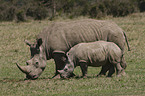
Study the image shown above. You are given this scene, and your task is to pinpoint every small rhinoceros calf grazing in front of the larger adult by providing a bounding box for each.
[58,41,125,78]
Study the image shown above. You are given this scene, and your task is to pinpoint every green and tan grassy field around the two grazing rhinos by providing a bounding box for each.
[0,13,145,96]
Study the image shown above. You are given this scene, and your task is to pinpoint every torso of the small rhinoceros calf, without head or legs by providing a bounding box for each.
[69,41,122,66]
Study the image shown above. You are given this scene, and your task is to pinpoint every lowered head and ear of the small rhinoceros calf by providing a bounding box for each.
[58,53,74,78]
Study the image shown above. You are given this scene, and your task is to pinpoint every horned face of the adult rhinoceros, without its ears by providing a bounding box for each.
[16,54,46,80]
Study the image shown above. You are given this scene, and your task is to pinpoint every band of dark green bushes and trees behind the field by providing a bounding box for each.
[0,0,145,21]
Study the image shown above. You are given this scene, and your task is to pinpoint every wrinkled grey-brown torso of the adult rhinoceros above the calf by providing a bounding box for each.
[38,19,124,55]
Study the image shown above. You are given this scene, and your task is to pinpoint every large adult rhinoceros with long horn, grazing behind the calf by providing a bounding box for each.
[17,19,129,79]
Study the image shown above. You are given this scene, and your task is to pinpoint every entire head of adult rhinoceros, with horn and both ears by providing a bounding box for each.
[17,38,46,79]
